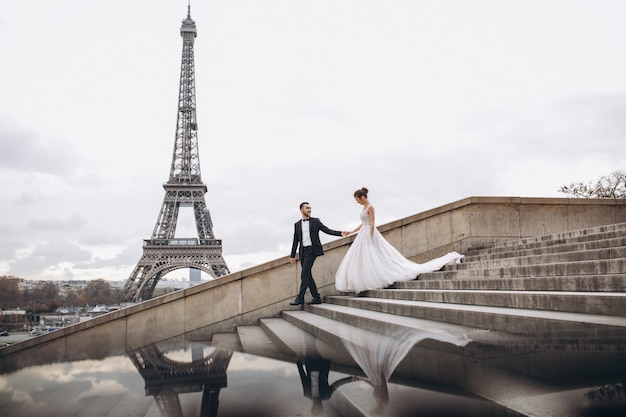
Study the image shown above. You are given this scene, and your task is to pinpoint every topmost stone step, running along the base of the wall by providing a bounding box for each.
[470,223,626,253]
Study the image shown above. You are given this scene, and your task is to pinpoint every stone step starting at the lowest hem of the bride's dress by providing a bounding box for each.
[368,289,626,317]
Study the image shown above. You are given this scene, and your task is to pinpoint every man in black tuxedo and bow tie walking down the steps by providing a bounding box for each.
[289,202,348,306]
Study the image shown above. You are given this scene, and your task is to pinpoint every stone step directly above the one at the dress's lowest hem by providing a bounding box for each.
[392,274,626,294]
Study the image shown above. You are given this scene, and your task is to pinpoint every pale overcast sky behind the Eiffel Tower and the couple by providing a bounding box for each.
[0,0,626,280]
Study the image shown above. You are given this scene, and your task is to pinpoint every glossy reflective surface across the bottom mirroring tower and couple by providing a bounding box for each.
[0,319,626,417]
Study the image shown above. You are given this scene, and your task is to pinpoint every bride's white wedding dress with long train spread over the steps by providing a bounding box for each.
[335,208,464,294]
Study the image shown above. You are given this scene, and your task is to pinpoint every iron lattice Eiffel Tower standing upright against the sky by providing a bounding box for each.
[124,5,230,301]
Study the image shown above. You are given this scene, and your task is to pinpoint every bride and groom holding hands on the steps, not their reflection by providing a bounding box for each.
[289,187,463,305]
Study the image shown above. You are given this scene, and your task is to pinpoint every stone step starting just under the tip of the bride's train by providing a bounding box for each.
[454,244,626,270]
